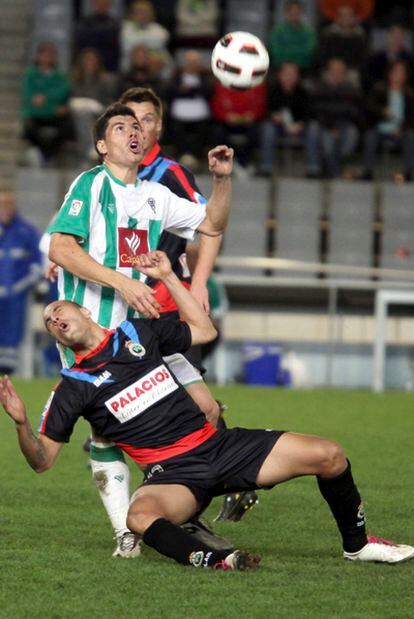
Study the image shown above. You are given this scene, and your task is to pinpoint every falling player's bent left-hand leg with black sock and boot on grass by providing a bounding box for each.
[127,484,259,569]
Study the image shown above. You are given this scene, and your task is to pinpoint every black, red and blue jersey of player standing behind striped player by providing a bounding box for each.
[137,144,206,312]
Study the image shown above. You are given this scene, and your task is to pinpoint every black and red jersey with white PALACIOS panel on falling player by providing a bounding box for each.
[39,317,215,464]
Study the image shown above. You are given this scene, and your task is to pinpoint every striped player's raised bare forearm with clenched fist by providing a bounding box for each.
[197,146,234,236]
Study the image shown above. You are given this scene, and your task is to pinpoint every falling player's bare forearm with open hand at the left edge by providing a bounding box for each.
[0,376,63,473]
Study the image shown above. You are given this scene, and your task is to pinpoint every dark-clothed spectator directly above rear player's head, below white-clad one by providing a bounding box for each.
[119,45,164,96]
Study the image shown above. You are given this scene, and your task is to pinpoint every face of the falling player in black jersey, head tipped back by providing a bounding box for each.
[43,301,91,348]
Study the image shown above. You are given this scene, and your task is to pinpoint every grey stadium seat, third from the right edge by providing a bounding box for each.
[274,178,322,278]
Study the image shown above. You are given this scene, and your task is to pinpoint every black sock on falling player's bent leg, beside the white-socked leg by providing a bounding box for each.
[142,518,229,567]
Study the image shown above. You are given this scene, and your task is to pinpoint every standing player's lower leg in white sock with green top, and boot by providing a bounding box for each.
[89,436,140,558]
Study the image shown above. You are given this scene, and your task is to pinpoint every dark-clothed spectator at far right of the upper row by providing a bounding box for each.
[365,26,413,86]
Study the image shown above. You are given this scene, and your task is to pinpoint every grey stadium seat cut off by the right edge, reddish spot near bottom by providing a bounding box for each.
[380,183,414,279]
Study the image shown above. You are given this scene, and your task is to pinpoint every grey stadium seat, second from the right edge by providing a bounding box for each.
[328,181,374,279]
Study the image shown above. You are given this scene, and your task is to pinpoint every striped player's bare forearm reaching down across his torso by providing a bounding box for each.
[49,232,160,318]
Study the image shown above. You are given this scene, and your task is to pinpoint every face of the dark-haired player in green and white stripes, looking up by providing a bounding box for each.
[97,116,144,168]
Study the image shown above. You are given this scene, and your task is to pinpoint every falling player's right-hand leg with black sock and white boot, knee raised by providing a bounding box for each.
[257,432,414,563]
